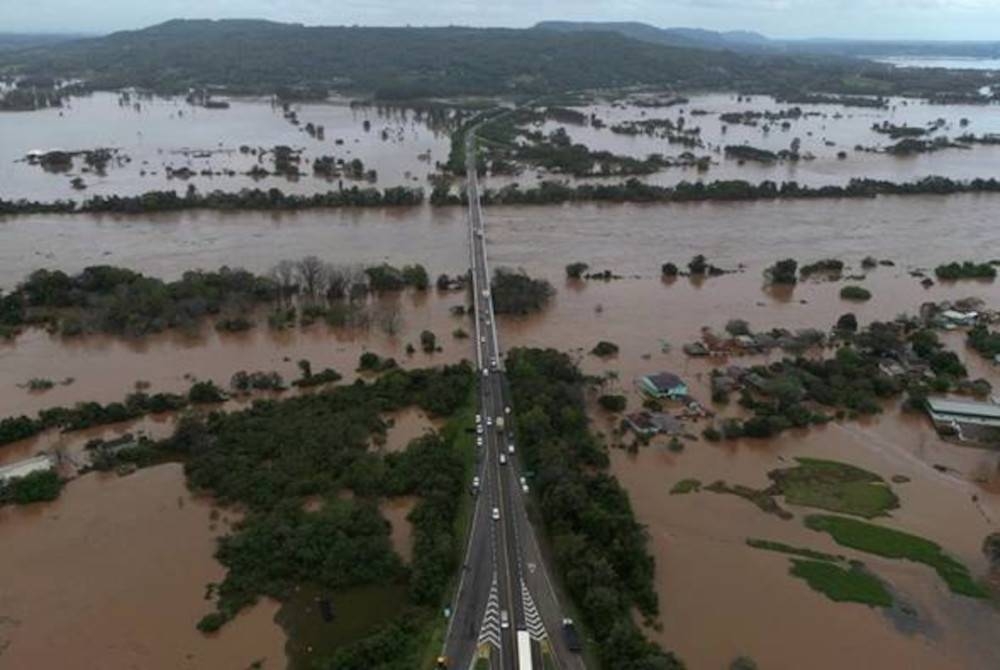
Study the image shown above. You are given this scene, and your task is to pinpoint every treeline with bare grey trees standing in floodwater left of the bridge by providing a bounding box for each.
[0,256,438,337]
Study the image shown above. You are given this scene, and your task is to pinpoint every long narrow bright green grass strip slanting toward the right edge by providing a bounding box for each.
[805,514,989,598]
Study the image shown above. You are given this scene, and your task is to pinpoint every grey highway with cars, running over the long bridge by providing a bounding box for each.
[442,123,584,670]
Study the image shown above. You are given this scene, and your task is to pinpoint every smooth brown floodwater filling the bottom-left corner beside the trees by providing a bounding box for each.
[0,465,285,670]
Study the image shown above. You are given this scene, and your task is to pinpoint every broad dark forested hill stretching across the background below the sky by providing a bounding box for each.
[0,20,988,98]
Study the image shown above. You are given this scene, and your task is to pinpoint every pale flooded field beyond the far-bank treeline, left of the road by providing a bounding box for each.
[0,93,449,200]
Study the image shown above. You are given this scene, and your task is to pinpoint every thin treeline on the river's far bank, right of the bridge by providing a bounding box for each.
[474,177,1000,205]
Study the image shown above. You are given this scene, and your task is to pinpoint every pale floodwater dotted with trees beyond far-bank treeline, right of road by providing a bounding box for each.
[536,94,1000,185]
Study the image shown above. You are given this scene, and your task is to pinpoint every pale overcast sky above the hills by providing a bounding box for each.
[0,0,1000,40]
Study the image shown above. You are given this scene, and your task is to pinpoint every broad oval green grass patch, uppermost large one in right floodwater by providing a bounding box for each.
[767,458,899,519]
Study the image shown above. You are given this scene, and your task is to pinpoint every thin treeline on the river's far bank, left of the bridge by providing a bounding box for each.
[0,186,424,215]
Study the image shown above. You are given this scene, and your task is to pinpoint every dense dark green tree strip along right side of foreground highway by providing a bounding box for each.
[507,349,683,670]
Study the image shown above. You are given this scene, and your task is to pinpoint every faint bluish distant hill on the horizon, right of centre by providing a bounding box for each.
[535,21,782,51]
